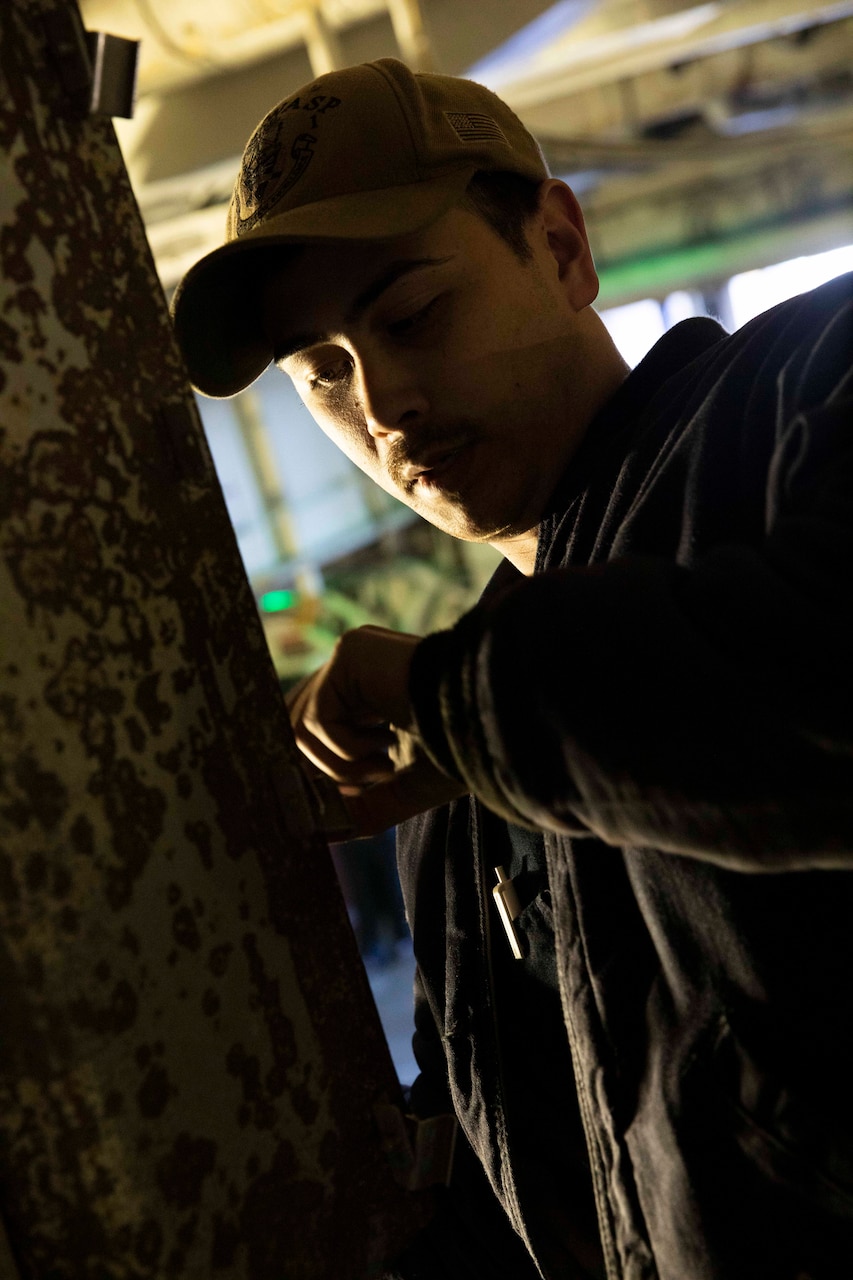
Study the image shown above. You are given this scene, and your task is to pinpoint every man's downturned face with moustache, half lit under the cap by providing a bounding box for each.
[258,192,601,547]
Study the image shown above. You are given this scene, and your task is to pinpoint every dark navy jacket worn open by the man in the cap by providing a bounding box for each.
[398,276,853,1280]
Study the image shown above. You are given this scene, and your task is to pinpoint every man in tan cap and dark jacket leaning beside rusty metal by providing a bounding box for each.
[174,60,853,1280]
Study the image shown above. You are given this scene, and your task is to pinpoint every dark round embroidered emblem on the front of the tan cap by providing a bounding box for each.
[232,93,341,234]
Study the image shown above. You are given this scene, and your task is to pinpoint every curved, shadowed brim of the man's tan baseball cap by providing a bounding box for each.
[172,168,475,399]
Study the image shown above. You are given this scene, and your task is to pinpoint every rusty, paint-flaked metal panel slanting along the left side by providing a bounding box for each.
[0,0,427,1280]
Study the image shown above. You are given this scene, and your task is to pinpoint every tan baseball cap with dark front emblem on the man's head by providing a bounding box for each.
[172,58,548,398]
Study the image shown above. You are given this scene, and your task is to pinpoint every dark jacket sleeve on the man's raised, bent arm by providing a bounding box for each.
[411,372,853,872]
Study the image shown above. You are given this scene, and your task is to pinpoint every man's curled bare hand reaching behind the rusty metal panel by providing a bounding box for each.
[287,626,465,836]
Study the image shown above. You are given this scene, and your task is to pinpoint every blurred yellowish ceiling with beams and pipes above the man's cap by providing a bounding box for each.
[81,0,853,305]
